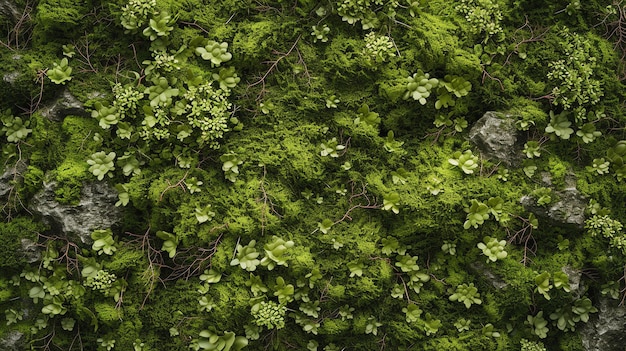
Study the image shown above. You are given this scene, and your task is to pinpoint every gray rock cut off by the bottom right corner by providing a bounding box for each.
[580,298,626,351]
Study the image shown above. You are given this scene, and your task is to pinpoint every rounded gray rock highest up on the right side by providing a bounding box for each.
[469,111,521,166]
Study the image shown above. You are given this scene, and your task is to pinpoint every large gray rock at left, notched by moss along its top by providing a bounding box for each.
[29,182,121,244]
